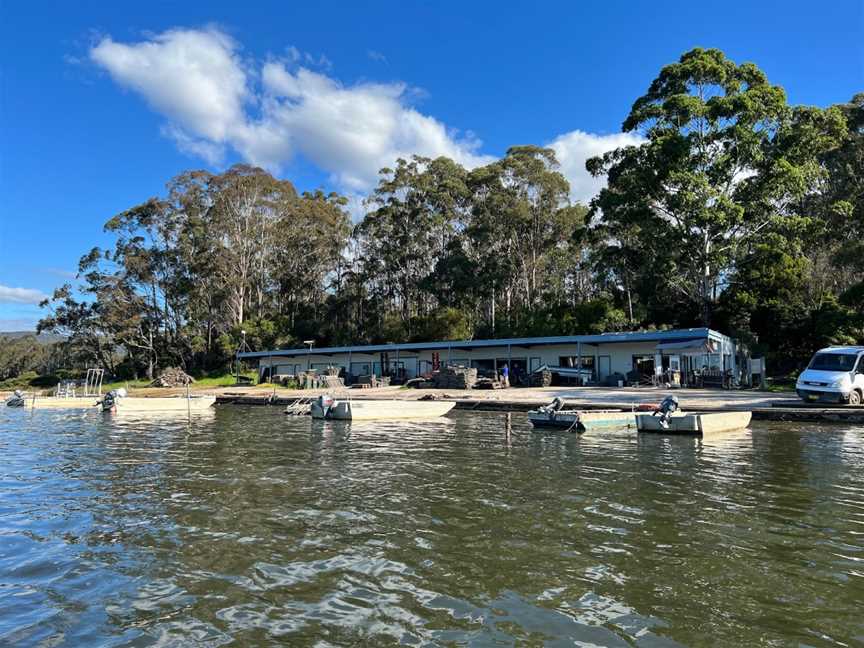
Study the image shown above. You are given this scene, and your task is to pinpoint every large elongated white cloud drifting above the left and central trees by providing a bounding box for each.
[90,28,492,191]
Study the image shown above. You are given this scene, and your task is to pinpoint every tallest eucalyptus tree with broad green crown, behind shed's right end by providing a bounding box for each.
[587,48,841,325]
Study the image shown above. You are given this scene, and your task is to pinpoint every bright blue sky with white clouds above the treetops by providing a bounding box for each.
[0,0,864,330]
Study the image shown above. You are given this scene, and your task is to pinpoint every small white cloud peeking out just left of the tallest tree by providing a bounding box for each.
[548,130,645,205]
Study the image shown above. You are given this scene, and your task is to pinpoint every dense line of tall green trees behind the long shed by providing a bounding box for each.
[40,49,864,376]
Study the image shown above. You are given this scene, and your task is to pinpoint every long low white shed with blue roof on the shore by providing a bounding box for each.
[239,328,744,383]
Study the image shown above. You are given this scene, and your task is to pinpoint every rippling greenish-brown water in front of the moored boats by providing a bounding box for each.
[0,408,864,647]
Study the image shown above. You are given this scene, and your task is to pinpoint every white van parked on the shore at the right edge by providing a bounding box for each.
[795,347,864,405]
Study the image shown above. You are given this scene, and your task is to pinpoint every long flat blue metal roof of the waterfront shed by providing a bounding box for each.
[239,328,728,358]
